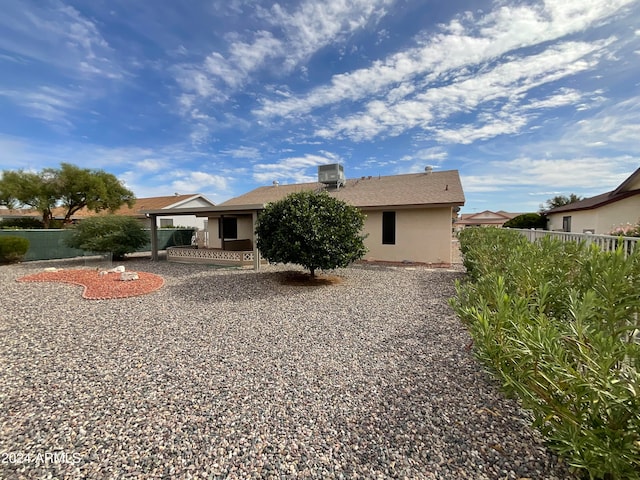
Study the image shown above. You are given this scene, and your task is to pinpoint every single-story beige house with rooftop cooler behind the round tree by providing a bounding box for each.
[144,164,465,268]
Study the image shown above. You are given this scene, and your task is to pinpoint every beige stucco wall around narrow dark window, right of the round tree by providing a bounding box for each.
[364,207,452,263]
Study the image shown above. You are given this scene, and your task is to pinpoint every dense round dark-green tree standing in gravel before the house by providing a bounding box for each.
[256,192,367,277]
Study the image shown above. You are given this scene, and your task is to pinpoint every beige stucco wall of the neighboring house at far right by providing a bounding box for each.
[547,195,640,234]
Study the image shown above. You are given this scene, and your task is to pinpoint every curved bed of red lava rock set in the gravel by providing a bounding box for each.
[17,269,164,300]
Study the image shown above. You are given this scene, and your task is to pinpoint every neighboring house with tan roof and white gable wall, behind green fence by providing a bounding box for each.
[0,193,215,230]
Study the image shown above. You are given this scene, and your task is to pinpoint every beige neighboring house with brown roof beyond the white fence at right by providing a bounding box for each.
[547,168,640,234]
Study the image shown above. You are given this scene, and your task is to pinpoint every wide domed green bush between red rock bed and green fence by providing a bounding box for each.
[66,215,149,260]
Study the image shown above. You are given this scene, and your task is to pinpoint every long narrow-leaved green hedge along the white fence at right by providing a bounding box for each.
[451,229,640,480]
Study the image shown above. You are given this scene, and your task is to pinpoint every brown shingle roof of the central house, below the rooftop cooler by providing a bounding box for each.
[219,170,465,208]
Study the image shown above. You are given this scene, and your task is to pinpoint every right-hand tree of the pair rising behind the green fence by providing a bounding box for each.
[55,163,135,224]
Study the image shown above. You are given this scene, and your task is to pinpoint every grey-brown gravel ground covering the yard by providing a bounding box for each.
[0,258,571,480]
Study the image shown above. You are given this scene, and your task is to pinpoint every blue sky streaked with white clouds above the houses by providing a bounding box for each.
[0,0,640,213]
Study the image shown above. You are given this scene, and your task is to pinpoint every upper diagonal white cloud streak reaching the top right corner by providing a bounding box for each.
[254,0,633,117]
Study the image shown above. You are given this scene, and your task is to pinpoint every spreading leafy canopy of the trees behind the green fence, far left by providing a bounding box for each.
[0,163,135,228]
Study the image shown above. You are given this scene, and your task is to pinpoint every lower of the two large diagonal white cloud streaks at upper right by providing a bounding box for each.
[316,40,611,143]
